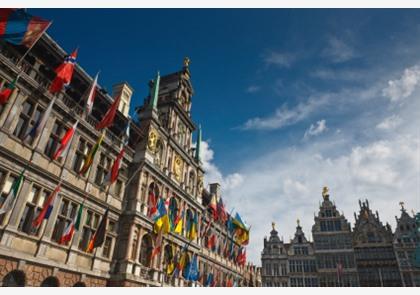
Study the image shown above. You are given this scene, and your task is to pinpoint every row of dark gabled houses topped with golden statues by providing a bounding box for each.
[261,188,420,287]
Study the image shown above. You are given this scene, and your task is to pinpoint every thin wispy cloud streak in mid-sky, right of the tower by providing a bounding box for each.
[239,95,329,130]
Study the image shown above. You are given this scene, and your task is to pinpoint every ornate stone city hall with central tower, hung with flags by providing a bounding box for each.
[0,34,260,286]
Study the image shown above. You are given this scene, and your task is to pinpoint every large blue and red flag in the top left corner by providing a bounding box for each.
[0,8,51,47]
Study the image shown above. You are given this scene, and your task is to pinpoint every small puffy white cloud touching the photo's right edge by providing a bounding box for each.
[383,65,420,102]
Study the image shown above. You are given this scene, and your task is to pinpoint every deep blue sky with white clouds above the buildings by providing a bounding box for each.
[29,9,420,264]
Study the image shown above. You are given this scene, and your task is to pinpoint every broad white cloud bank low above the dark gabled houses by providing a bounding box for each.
[218,63,420,264]
